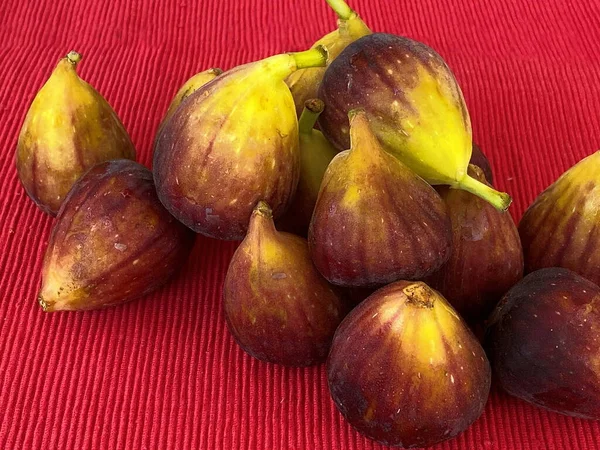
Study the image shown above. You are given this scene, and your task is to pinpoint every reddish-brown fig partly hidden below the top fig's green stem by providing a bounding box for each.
[427,165,523,324]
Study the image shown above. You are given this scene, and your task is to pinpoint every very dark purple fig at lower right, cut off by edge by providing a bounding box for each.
[488,267,600,420]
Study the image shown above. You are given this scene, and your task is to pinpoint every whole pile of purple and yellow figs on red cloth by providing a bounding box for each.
[16,0,600,447]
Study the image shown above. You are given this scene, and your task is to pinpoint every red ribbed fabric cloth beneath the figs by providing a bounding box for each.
[0,0,600,450]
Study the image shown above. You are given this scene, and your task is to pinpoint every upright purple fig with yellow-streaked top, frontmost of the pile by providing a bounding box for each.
[327,281,491,448]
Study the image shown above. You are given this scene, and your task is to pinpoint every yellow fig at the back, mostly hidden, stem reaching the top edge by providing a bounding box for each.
[286,0,371,117]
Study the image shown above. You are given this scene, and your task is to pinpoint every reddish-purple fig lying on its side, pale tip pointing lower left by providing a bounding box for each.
[38,160,195,311]
